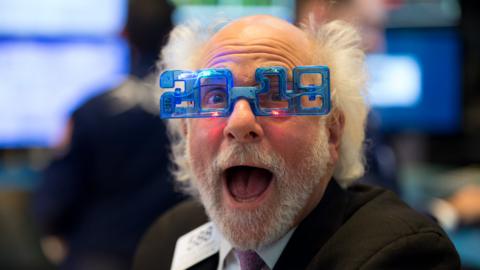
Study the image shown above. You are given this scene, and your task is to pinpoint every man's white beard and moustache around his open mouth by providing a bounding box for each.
[187,126,330,249]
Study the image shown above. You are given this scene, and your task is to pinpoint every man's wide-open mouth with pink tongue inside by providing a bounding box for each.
[228,167,272,200]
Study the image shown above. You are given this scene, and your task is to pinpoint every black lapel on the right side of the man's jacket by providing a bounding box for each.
[274,179,348,270]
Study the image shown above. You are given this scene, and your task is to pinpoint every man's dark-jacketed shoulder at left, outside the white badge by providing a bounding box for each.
[133,200,208,270]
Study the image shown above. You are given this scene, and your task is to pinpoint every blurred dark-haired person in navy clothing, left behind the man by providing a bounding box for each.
[30,0,181,270]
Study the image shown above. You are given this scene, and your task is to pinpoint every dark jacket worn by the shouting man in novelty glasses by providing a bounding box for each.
[134,180,460,270]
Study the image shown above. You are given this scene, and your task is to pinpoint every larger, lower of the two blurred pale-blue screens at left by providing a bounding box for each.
[0,39,129,148]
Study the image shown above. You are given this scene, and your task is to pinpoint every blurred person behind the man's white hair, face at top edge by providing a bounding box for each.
[296,0,401,195]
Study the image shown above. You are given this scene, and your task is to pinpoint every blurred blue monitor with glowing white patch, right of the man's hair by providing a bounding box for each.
[367,28,462,133]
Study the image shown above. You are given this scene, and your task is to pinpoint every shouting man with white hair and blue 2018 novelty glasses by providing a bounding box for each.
[134,16,460,270]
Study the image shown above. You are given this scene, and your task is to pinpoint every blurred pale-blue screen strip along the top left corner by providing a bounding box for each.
[0,0,127,36]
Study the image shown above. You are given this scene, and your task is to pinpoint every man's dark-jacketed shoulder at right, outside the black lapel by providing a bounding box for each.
[317,186,460,269]
